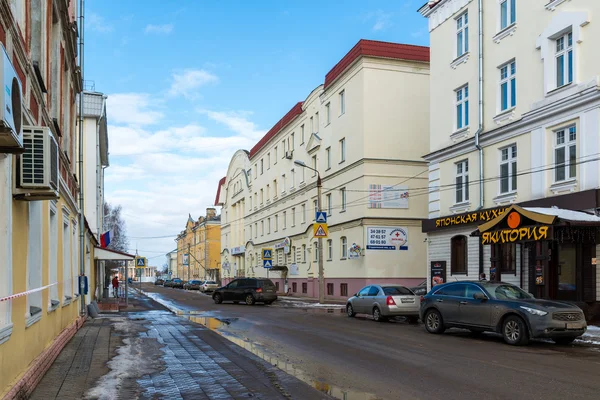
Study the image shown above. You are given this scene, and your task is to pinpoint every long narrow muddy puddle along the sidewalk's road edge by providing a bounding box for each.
[185,312,380,400]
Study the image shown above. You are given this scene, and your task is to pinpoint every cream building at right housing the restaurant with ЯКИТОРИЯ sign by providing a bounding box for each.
[420,0,600,310]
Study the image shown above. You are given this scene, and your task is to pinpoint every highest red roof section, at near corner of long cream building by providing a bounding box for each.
[325,39,429,88]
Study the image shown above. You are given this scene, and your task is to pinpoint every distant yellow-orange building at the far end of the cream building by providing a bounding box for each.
[172,208,221,281]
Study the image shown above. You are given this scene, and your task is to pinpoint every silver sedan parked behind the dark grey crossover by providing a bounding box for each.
[346,285,421,322]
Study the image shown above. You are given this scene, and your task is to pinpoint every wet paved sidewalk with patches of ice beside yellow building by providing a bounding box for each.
[31,291,328,400]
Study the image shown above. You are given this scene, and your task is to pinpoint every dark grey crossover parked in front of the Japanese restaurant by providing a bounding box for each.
[421,281,587,345]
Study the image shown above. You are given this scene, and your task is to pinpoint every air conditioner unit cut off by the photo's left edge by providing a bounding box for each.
[0,44,25,153]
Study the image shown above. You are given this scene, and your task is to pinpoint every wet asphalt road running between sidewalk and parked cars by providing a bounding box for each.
[138,285,600,400]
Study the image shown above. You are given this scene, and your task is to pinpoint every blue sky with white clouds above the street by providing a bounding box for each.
[84,0,429,267]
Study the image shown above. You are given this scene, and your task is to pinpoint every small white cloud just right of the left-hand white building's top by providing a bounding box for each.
[106,93,164,125]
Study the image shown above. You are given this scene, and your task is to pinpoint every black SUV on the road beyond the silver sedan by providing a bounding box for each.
[212,278,277,305]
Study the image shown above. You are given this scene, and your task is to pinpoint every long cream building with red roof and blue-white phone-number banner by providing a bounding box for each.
[216,40,429,297]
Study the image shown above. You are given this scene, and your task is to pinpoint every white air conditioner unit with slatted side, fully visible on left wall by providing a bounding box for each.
[15,126,59,201]
